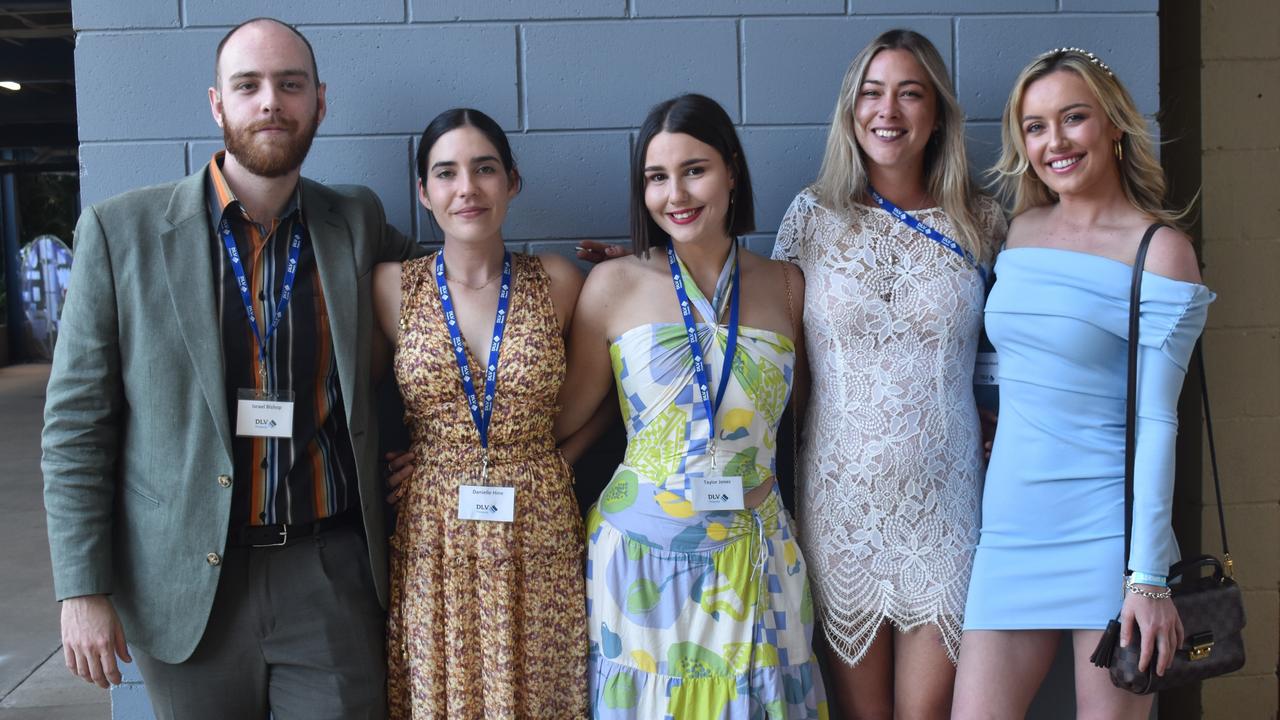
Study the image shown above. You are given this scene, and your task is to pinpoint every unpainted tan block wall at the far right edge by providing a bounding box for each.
[1199,0,1280,720]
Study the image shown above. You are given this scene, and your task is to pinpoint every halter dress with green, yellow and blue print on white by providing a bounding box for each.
[586,248,827,720]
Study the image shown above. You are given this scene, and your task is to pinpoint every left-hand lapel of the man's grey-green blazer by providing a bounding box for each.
[160,170,232,457]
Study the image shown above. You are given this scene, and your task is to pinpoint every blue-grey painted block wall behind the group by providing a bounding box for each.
[72,0,1158,720]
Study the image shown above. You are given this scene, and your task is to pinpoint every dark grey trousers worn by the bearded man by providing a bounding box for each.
[133,520,387,720]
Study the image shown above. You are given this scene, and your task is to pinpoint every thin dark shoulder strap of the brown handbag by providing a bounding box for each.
[1124,223,1233,578]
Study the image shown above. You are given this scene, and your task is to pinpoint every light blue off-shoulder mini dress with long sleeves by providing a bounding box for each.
[965,247,1215,630]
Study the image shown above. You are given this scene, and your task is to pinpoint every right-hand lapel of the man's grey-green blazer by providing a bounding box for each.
[302,179,360,423]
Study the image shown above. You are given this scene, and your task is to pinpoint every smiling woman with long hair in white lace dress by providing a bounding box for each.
[773,29,1005,717]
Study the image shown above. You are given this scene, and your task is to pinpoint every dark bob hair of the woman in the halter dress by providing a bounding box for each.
[631,94,755,255]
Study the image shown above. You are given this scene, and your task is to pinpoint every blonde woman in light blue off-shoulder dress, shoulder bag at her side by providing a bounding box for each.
[952,49,1213,719]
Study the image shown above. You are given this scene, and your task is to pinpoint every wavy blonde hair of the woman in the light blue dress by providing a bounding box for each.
[988,47,1190,227]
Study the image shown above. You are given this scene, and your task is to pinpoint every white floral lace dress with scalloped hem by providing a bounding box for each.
[773,190,1006,665]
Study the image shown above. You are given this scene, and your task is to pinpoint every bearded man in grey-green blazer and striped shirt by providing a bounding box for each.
[42,18,415,719]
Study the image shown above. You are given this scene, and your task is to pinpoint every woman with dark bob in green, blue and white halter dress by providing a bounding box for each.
[557,95,826,720]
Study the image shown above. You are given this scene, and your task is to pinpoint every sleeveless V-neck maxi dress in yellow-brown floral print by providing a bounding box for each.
[387,254,588,720]
